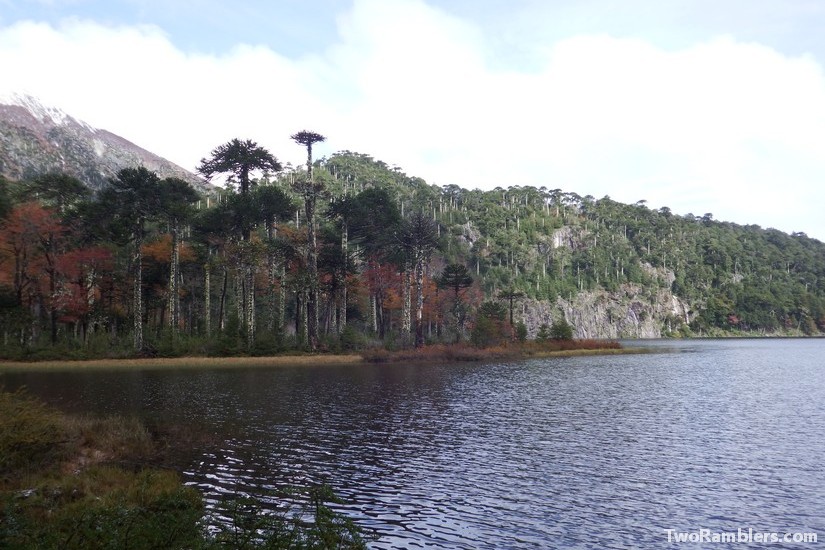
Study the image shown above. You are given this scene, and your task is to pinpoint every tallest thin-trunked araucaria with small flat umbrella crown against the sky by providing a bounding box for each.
[291,130,326,350]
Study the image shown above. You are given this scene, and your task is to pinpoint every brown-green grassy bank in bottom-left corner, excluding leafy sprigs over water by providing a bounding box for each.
[0,391,203,548]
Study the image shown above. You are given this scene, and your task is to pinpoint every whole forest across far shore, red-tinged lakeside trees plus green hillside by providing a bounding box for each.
[0,140,825,358]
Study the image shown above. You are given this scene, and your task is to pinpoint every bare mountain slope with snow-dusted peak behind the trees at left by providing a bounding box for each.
[0,94,210,192]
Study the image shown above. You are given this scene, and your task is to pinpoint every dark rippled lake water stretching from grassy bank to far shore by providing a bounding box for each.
[0,339,825,548]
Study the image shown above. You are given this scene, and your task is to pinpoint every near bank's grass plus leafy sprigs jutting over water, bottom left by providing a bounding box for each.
[0,391,367,549]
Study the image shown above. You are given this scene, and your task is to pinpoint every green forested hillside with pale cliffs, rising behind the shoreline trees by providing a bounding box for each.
[322,152,825,337]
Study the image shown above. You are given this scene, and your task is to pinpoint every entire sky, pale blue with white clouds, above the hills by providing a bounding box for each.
[0,0,825,240]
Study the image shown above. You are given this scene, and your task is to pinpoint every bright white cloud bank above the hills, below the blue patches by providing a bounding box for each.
[0,0,825,239]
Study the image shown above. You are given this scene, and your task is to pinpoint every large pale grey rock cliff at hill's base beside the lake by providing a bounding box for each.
[521,284,692,338]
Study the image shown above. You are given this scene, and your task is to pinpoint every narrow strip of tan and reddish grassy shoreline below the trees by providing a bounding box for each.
[0,347,651,373]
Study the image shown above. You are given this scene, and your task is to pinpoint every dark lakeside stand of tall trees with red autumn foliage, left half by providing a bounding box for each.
[0,137,502,356]
